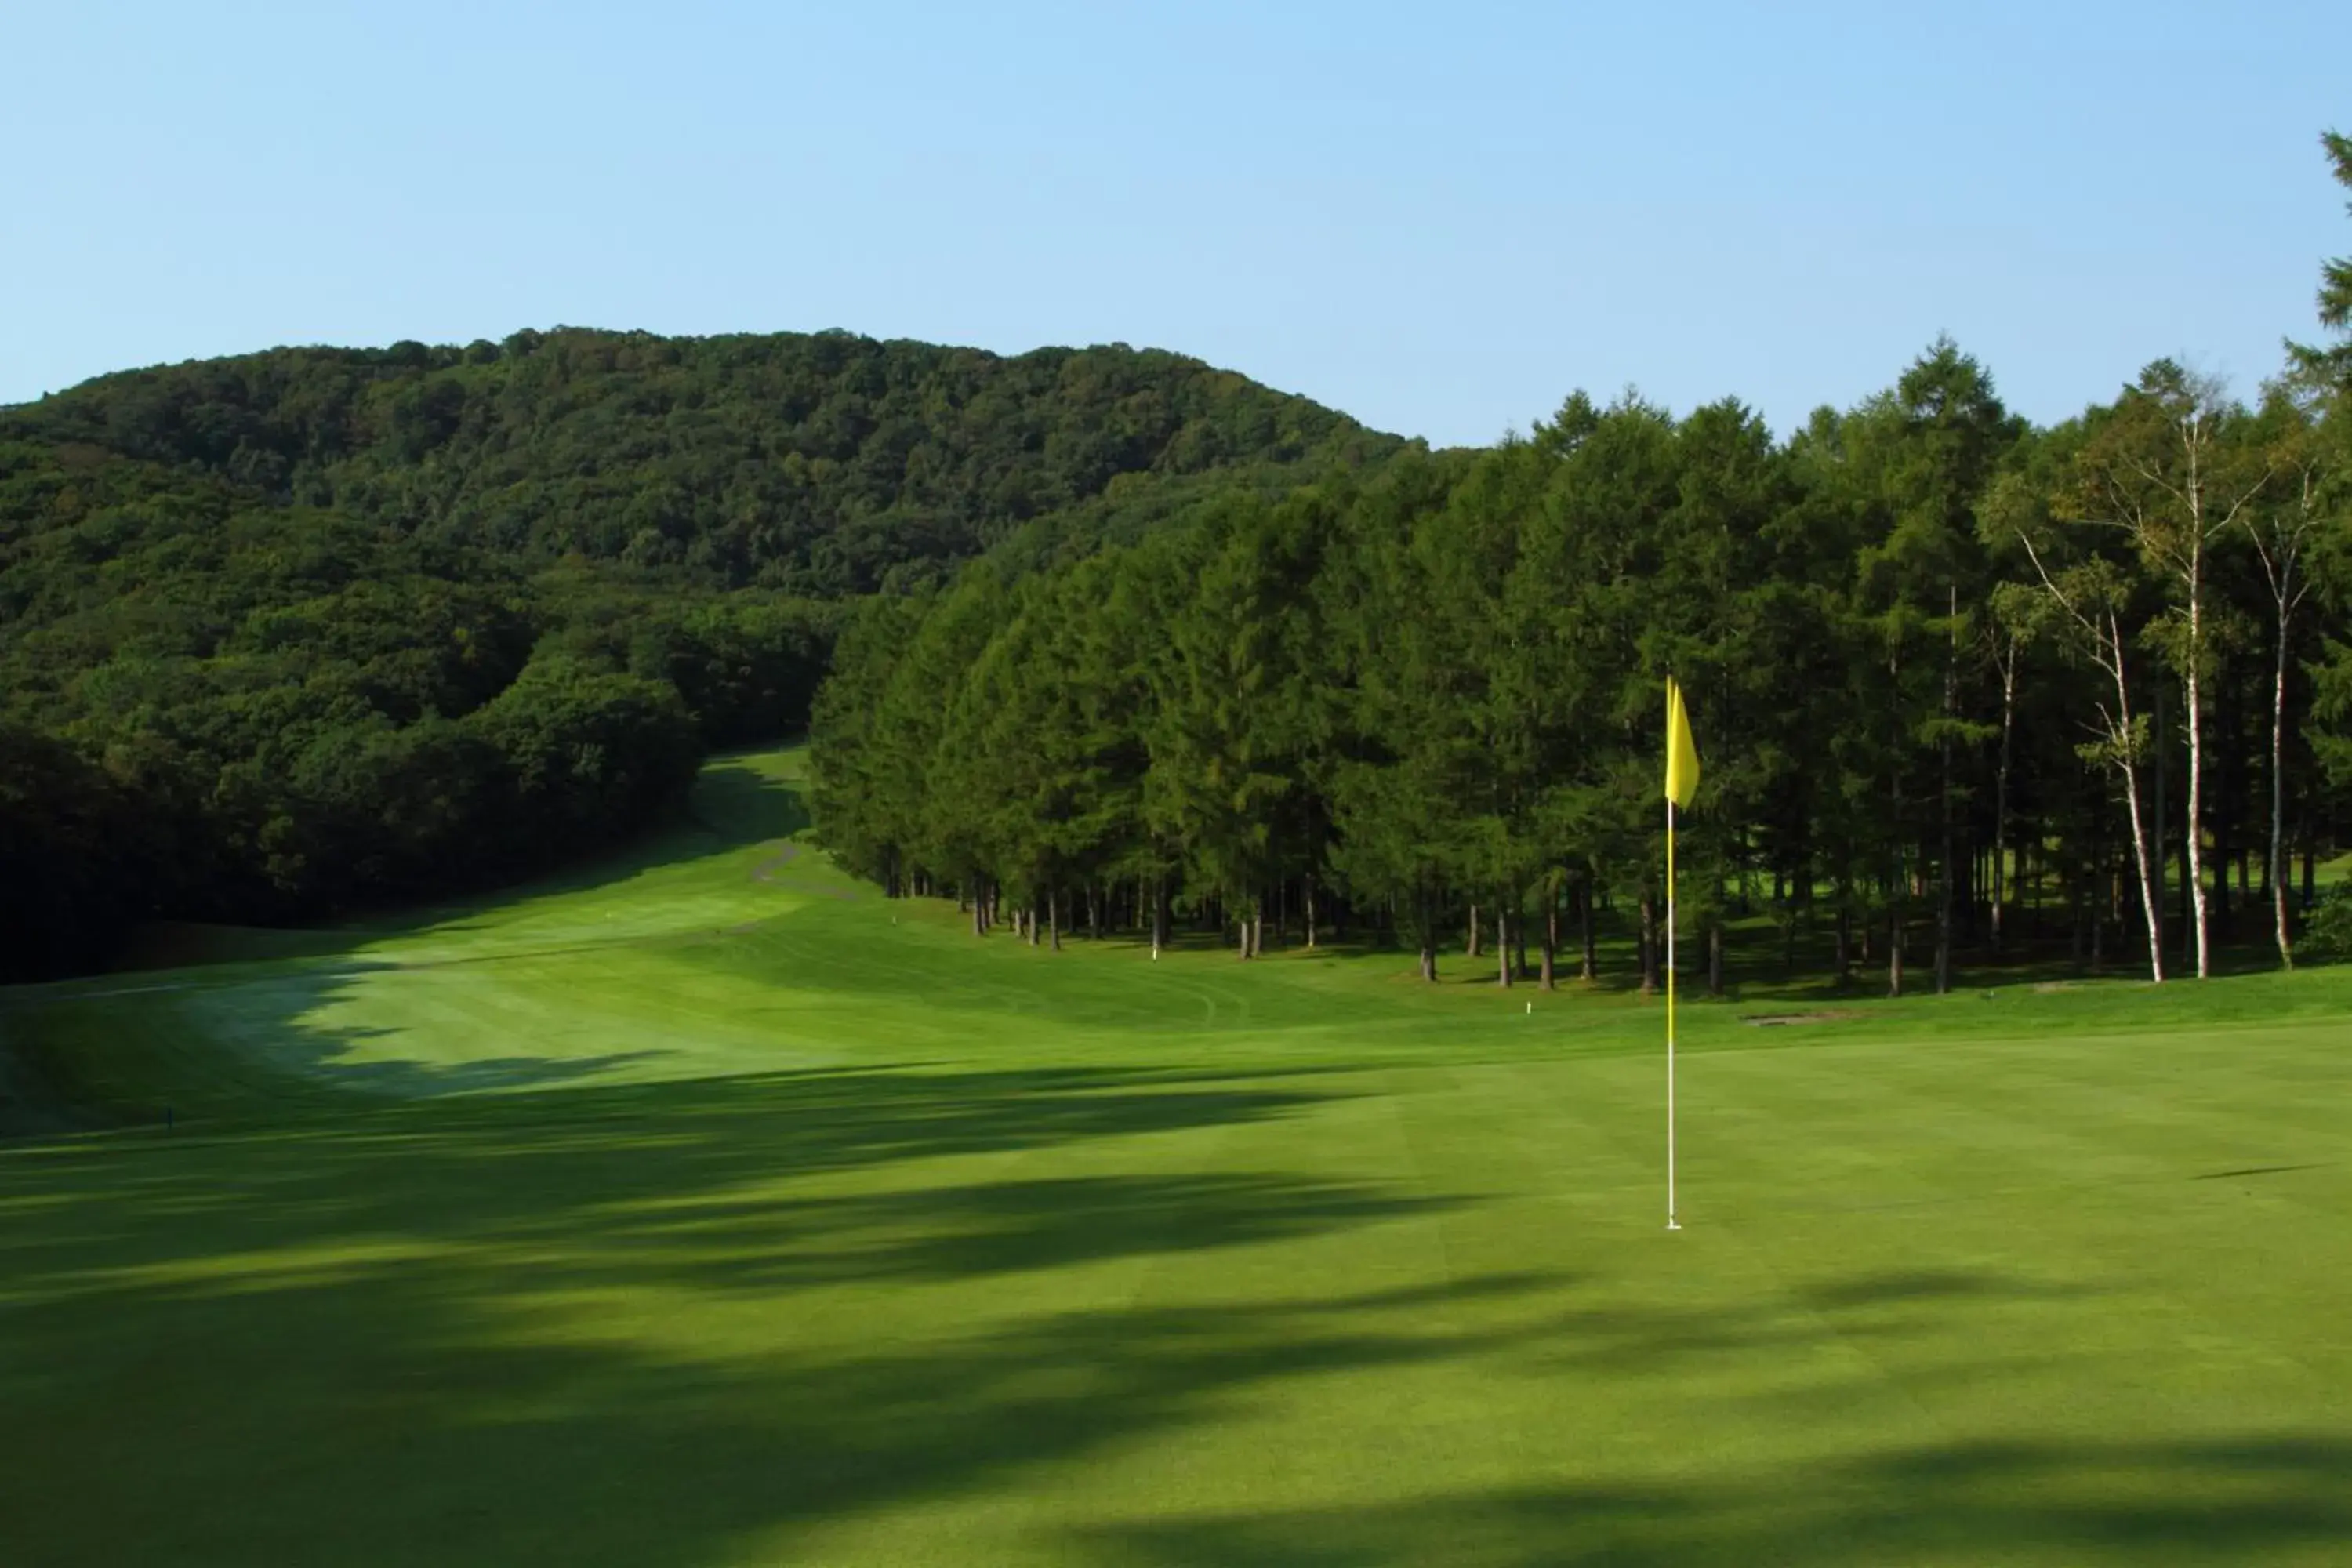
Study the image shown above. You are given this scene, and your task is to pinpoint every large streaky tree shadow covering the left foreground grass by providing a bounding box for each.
[0,1053,1545,1566]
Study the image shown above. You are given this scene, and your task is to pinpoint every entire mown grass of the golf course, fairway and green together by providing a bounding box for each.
[0,753,2352,1568]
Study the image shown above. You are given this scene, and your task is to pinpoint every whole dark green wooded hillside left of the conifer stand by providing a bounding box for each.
[0,329,1404,978]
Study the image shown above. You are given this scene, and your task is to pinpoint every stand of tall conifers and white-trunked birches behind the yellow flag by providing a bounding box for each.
[814,136,2352,992]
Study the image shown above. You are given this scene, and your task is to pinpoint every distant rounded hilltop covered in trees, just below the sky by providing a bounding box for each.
[0,329,1402,597]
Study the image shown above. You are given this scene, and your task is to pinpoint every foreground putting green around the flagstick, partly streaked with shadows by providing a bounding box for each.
[0,1041,2352,1566]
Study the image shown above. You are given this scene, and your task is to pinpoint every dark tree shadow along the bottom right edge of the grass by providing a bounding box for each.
[1098,1436,2352,1568]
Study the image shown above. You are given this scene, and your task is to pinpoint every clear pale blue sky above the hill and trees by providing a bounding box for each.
[0,0,2352,442]
